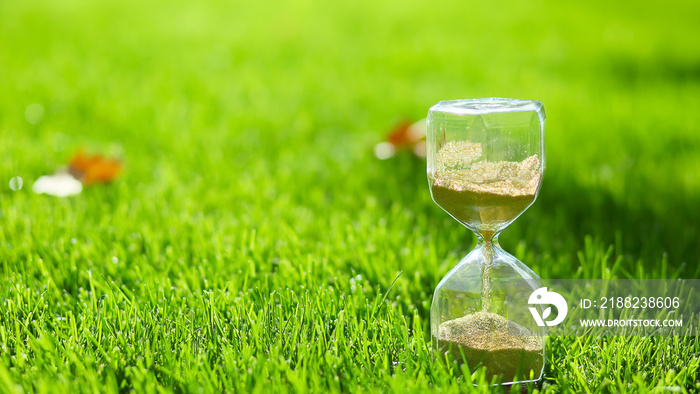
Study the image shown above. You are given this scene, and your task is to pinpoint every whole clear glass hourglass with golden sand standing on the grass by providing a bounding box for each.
[426,98,545,385]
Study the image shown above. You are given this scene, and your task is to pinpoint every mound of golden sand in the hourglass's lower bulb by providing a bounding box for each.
[438,311,544,381]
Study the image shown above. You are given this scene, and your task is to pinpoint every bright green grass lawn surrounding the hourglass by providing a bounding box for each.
[0,0,700,392]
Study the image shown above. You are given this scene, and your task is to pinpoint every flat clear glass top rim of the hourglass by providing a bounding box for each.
[430,97,545,119]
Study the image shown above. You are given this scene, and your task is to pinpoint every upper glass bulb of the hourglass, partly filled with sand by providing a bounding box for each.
[426,98,545,238]
